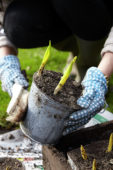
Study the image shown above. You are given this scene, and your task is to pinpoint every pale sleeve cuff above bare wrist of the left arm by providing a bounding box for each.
[0,28,17,53]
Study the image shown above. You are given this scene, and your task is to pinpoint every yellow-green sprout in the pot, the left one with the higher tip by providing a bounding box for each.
[37,41,51,77]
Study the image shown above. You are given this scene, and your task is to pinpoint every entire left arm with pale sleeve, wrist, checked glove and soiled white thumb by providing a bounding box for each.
[0,33,29,122]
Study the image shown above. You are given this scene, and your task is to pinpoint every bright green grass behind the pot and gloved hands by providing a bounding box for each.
[0,47,113,129]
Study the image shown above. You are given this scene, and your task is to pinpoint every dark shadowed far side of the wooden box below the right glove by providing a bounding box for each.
[55,120,113,153]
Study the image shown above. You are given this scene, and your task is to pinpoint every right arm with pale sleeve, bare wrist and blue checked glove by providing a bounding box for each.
[63,27,113,135]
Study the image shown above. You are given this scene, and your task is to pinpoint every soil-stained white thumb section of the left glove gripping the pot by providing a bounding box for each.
[6,84,29,123]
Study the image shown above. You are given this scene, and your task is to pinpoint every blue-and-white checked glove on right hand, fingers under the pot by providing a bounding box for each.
[63,67,107,135]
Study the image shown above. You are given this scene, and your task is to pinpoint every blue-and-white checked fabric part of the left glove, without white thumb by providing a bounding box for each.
[0,55,28,96]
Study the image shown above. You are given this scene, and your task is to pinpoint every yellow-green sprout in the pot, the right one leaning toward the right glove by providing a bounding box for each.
[54,57,77,95]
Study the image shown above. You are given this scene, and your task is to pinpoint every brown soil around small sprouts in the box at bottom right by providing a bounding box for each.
[68,140,113,170]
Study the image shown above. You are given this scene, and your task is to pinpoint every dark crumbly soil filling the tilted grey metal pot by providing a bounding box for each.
[34,70,82,110]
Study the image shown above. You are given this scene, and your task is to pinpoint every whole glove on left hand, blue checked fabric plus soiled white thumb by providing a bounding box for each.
[0,55,28,122]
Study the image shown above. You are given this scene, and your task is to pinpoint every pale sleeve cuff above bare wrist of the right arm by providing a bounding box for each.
[101,27,113,56]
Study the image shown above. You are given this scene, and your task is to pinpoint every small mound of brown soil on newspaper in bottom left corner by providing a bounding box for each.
[0,158,25,170]
